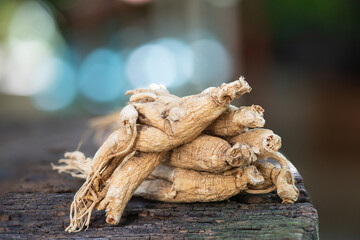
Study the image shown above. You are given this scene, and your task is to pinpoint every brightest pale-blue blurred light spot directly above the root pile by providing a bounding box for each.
[125,38,195,88]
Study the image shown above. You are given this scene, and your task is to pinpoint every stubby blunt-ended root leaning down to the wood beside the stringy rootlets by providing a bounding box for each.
[98,152,165,225]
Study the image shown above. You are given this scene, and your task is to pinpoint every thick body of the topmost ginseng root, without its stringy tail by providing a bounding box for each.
[133,78,251,152]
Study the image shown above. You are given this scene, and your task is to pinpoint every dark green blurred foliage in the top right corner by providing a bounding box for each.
[265,0,360,40]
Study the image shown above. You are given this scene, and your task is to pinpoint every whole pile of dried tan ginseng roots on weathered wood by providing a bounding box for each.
[53,77,299,232]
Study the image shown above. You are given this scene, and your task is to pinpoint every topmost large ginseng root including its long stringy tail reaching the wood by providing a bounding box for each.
[58,78,251,232]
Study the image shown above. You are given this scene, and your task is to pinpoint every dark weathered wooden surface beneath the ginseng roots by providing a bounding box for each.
[0,117,318,239]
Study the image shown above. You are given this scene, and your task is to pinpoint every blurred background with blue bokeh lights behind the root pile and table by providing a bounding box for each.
[0,0,360,239]
